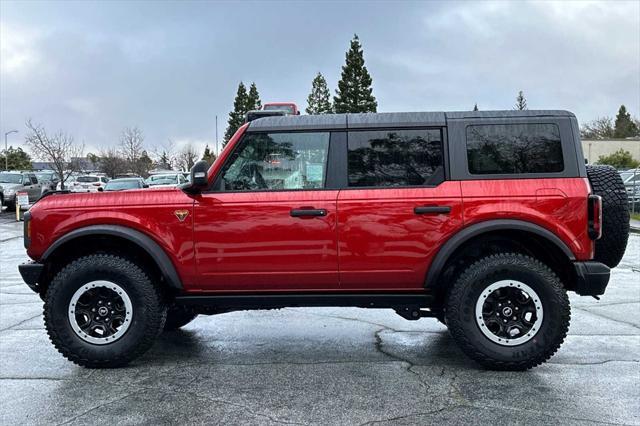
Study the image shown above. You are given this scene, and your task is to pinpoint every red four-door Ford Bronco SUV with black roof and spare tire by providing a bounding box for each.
[20,111,629,370]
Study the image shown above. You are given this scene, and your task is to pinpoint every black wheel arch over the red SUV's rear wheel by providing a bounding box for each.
[424,219,576,289]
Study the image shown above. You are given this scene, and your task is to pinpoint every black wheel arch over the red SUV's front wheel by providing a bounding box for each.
[40,225,183,290]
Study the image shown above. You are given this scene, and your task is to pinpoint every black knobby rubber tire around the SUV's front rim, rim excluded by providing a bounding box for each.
[44,254,166,368]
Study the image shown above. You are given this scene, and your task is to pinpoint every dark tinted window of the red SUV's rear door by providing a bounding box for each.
[347,129,444,187]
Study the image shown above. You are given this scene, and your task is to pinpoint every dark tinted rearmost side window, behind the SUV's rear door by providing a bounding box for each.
[466,124,564,175]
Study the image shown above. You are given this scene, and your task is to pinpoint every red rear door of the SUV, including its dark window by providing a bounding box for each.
[338,128,462,291]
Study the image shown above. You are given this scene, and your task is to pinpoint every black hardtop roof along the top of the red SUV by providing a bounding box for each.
[247,110,574,132]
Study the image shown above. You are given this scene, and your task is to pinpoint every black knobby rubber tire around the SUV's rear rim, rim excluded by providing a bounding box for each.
[446,253,571,370]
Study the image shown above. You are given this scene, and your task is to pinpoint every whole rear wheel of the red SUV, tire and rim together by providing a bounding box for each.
[446,253,571,370]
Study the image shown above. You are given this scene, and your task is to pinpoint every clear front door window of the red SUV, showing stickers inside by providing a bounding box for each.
[222,132,329,191]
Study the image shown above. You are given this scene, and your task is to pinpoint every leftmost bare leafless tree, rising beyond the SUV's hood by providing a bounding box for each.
[25,120,84,189]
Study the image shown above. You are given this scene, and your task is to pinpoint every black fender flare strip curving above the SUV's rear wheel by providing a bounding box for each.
[424,219,576,288]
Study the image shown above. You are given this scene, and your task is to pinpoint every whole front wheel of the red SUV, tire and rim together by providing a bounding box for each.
[44,254,166,368]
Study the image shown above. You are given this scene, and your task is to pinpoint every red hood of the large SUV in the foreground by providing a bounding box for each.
[32,188,193,210]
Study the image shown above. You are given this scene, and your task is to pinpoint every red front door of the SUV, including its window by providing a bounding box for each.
[194,132,338,292]
